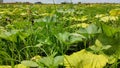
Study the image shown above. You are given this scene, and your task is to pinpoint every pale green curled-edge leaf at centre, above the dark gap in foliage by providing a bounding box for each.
[56,32,85,44]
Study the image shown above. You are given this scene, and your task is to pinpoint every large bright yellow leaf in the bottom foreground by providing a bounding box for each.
[64,49,108,68]
